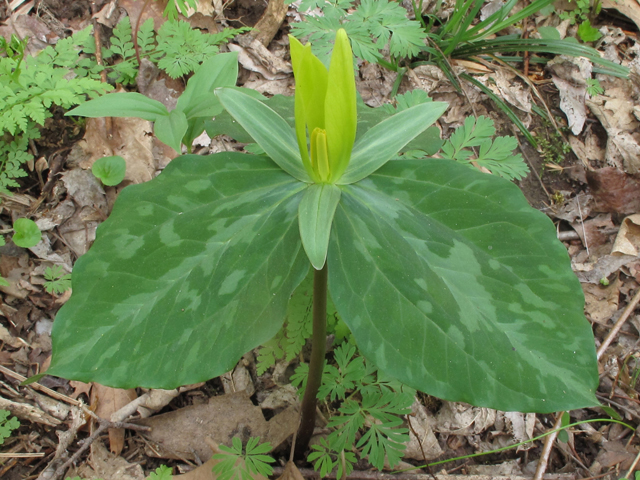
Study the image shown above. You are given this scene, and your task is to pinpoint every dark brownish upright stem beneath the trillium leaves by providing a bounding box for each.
[295,263,327,458]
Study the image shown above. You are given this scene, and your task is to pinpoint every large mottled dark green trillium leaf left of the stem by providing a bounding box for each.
[47,152,309,388]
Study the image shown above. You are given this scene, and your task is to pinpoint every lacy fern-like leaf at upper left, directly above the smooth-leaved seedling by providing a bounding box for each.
[76,16,250,85]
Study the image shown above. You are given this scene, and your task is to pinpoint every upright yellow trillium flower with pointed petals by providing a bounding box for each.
[289,29,357,183]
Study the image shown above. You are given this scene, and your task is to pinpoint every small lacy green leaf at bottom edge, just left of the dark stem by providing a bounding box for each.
[213,437,275,480]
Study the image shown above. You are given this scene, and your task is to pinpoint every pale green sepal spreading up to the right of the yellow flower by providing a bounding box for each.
[338,102,448,184]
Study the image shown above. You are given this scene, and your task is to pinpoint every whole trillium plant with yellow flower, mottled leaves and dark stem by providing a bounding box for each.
[47,30,598,454]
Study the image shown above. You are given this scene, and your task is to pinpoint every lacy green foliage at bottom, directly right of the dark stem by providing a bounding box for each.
[292,344,415,472]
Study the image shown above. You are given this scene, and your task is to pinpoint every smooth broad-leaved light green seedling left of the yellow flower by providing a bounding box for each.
[66,53,238,153]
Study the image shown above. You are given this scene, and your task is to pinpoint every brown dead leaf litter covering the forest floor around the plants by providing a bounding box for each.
[0,0,640,480]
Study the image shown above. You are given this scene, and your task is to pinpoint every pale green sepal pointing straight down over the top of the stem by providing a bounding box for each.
[298,183,341,270]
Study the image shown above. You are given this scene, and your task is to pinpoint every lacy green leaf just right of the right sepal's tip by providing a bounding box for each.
[442,116,529,180]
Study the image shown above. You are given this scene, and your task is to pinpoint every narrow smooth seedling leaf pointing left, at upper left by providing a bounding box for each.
[65,92,169,122]
